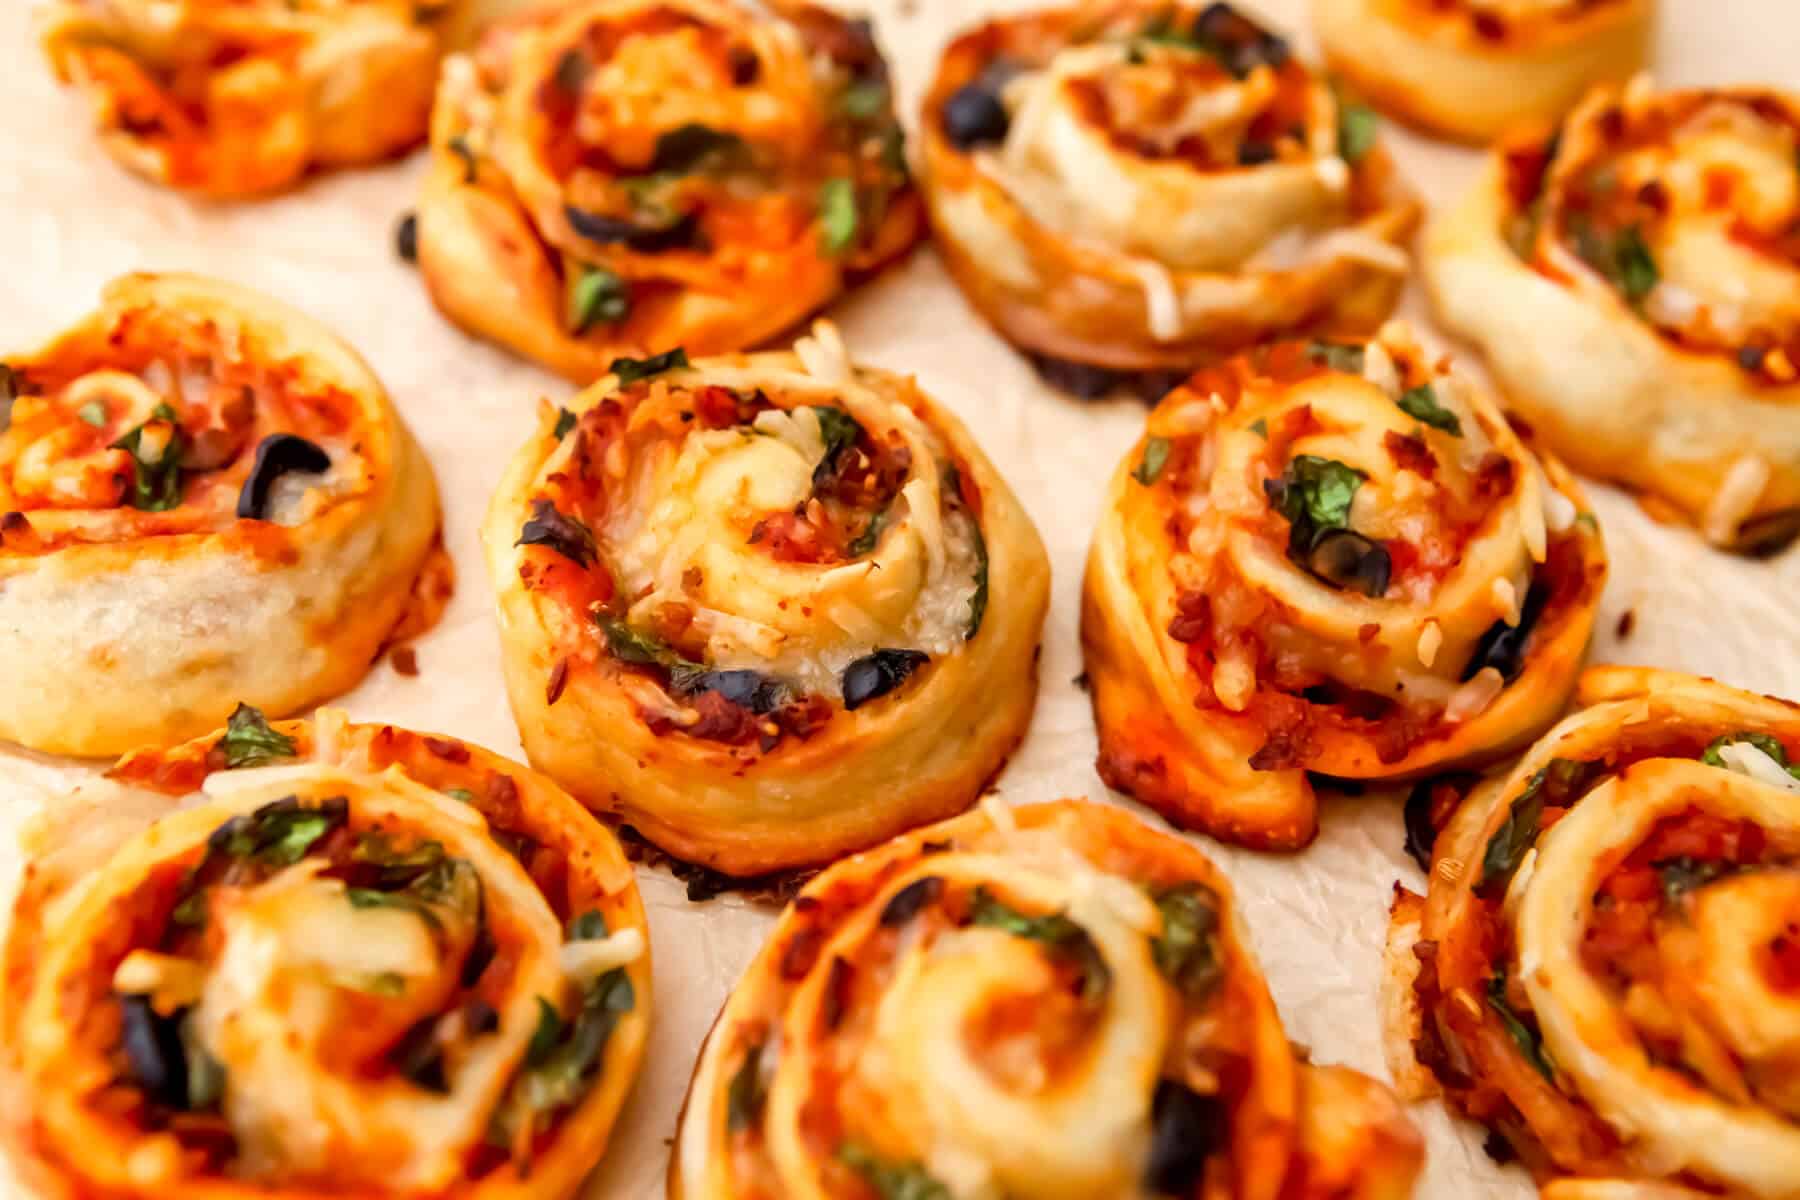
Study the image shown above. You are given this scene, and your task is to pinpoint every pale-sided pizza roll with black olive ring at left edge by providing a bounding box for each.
[0,275,452,756]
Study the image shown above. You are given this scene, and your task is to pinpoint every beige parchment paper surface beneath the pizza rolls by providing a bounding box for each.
[0,0,1800,1200]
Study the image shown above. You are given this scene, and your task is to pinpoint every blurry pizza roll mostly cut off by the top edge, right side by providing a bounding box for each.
[1312,0,1656,142]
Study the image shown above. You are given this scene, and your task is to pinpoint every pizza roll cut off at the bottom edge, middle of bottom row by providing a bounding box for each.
[668,801,1422,1200]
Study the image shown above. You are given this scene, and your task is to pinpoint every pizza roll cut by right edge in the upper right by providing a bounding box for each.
[1426,81,1800,549]
